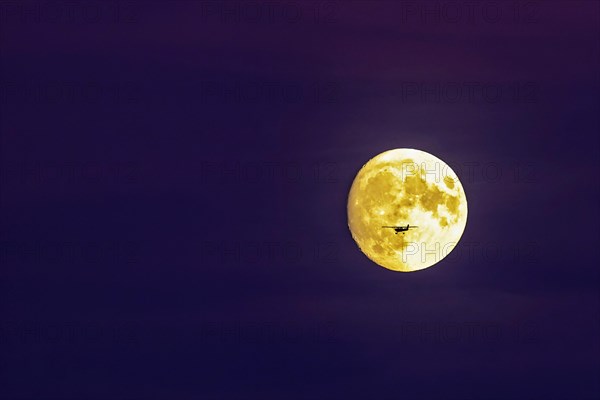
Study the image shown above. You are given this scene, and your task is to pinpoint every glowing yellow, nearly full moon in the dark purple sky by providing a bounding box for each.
[348,149,467,272]
